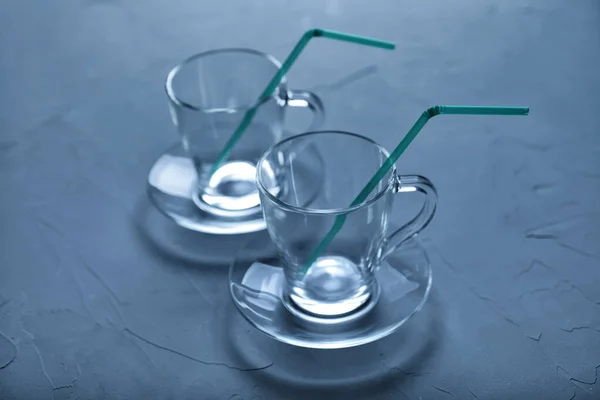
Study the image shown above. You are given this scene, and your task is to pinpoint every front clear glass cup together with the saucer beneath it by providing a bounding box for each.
[230,131,437,348]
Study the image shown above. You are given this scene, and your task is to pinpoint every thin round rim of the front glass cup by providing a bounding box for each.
[256,130,396,215]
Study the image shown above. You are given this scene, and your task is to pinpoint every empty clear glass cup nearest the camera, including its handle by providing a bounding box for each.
[257,131,437,318]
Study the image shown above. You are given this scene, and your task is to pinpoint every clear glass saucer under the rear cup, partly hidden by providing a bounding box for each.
[147,143,322,235]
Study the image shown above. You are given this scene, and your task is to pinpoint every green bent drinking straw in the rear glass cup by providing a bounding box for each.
[210,29,396,176]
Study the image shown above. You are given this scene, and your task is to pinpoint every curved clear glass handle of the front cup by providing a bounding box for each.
[381,175,437,258]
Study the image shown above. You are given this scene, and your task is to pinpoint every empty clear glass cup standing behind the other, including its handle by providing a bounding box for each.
[166,49,323,220]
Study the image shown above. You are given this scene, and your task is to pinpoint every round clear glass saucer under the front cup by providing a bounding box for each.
[229,237,432,349]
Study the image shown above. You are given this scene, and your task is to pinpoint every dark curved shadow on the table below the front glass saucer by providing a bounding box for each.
[226,290,444,399]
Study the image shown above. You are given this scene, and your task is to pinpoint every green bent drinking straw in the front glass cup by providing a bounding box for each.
[303,106,529,274]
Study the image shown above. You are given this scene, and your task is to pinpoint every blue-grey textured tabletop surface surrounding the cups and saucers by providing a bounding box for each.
[0,0,600,400]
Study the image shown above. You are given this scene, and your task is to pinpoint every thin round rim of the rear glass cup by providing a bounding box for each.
[165,47,286,111]
